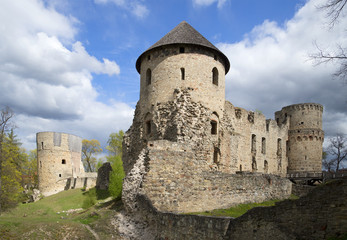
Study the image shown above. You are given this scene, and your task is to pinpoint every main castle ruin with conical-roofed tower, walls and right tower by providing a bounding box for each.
[122,22,324,212]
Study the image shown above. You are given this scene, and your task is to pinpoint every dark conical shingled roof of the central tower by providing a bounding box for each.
[136,21,230,73]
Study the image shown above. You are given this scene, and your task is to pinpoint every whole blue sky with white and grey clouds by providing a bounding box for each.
[0,0,347,153]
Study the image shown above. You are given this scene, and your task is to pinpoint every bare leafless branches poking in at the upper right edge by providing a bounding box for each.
[311,0,347,82]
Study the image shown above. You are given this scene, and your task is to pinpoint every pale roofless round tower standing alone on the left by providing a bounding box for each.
[36,132,84,196]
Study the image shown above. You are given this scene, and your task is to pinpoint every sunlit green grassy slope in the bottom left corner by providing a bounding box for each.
[0,189,121,239]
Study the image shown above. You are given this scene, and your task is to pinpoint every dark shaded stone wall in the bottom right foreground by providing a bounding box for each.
[134,179,347,240]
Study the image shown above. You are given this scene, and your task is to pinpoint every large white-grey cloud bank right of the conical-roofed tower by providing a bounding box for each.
[218,0,347,139]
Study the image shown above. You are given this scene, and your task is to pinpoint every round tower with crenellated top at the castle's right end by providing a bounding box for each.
[275,103,324,173]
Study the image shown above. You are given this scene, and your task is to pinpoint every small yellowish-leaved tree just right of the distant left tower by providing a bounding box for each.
[82,139,102,172]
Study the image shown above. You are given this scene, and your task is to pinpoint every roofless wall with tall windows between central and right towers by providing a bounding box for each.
[225,102,288,176]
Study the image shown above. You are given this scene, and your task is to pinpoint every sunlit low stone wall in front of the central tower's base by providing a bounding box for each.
[141,140,291,212]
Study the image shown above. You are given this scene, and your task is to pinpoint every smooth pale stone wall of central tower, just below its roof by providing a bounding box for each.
[139,45,225,117]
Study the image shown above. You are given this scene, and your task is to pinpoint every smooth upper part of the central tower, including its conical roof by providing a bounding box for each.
[136,21,230,117]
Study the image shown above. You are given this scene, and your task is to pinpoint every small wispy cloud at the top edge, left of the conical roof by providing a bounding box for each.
[94,0,149,18]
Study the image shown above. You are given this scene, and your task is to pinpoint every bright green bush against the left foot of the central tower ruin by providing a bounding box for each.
[107,155,125,198]
